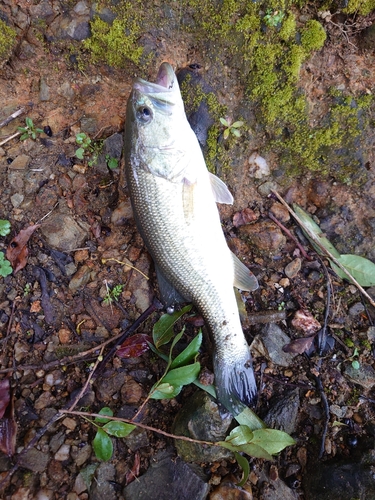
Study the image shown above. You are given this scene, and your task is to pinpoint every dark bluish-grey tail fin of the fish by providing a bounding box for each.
[214,351,257,416]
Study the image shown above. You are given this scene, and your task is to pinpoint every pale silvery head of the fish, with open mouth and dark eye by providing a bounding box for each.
[125,62,200,180]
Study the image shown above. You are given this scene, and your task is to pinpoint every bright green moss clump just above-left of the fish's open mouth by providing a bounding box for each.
[83,15,143,67]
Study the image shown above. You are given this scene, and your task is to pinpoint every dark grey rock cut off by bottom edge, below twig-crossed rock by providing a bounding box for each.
[124,452,210,500]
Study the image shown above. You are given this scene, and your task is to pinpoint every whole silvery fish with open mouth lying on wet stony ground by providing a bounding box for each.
[124,62,259,416]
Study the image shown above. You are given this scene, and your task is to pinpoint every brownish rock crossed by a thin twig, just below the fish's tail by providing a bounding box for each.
[173,391,232,463]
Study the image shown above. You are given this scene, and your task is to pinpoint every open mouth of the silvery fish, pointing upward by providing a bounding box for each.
[133,62,179,102]
